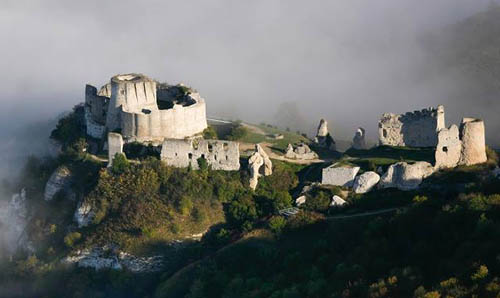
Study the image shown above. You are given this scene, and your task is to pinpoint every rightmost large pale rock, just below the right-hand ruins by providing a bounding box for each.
[379,161,434,191]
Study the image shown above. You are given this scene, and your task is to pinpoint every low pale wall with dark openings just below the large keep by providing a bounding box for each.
[161,139,240,171]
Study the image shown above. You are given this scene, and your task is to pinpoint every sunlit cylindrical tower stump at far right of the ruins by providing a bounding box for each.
[460,118,488,166]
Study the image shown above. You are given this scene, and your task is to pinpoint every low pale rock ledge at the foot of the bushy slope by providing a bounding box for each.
[64,246,164,273]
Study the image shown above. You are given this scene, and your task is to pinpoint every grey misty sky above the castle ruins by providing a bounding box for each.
[0,0,491,182]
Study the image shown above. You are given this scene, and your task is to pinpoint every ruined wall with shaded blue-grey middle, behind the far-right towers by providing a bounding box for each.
[379,105,445,147]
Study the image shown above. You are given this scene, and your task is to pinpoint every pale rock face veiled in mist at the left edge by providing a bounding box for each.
[0,189,32,254]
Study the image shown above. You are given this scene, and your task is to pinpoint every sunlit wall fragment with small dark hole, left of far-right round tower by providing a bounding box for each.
[435,125,462,169]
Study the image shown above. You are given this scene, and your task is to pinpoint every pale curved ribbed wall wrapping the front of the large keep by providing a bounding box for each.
[121,94,207,141]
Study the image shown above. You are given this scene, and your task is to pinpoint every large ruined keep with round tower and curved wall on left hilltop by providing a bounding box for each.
[85,73,207,144]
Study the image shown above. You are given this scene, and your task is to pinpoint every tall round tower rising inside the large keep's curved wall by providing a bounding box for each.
[106,73,157,131]
